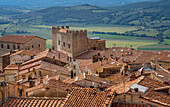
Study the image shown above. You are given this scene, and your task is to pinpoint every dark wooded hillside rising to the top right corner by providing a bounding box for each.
[108,0,170,27]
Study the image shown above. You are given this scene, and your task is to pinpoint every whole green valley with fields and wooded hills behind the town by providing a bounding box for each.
[0,0,170,49]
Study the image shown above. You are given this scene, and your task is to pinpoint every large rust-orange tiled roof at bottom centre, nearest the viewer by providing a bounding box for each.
[62,88,114,107]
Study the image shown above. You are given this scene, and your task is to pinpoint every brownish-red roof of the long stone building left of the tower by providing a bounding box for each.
[0,35,46,43]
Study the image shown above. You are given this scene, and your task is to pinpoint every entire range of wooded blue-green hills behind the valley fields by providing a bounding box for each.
[13,0,170,27]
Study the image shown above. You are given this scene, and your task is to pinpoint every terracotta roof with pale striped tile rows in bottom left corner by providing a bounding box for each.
[1,97,65,107]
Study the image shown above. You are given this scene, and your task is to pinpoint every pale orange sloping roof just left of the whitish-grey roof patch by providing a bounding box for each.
[108,76,144,94]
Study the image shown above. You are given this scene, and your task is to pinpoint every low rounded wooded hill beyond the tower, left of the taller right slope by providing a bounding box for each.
[13,4,112,25]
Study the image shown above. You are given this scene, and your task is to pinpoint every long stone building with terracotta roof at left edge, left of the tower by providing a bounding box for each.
[0,35,46,72]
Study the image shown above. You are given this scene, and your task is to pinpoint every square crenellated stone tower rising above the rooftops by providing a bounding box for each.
[52,26,87,58]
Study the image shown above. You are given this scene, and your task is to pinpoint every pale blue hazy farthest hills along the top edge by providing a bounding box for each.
[0,0,157,7]
